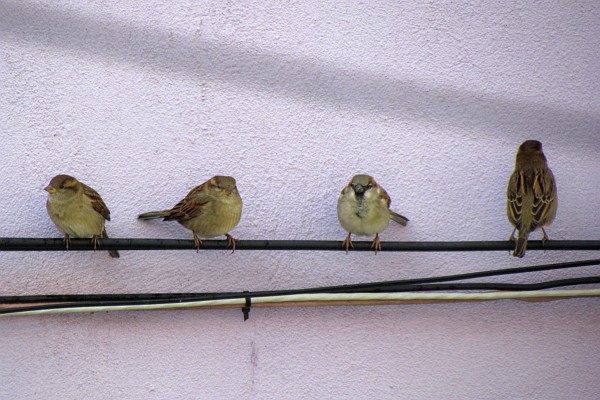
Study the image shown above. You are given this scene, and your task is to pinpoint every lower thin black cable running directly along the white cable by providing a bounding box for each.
[0,276,600,314]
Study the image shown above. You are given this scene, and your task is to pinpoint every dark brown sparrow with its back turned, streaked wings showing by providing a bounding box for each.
[506,140,558,257]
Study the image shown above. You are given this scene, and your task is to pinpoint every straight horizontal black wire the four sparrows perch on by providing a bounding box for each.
[0,238,600,252]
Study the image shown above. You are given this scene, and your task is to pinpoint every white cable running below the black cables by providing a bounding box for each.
[0,289,600,317]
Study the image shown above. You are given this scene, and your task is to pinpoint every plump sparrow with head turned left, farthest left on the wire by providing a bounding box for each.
[44,175,119,257]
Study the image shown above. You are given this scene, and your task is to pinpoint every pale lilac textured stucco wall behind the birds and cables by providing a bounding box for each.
[0,0,600,399]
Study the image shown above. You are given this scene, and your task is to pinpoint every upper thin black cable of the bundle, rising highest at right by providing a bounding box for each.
[0,259,600,304]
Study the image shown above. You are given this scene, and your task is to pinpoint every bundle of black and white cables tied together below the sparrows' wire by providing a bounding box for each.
[0,258,600,320]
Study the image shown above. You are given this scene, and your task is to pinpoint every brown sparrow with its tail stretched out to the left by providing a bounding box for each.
[138,176,242,251]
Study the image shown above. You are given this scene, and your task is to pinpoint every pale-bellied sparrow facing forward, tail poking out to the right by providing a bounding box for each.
[337,175,408,254]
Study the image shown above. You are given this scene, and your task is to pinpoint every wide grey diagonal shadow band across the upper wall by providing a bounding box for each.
[0,0,600,149]
